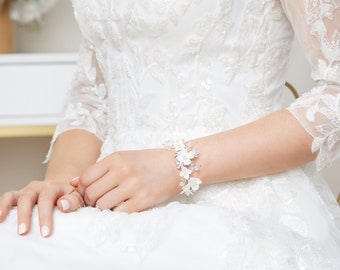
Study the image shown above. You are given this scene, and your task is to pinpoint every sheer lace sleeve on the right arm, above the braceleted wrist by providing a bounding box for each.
[281,0,340,169]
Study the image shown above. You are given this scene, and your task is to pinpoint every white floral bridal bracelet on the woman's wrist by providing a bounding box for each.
[168,141,202,196]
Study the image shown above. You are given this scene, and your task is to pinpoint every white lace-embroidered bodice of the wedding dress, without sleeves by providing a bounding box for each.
[74,0,293,152]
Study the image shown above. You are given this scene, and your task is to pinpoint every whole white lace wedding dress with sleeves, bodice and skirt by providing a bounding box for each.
[0,0,340,270]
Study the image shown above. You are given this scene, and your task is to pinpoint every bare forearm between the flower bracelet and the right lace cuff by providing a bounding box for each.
[192,110,316,184]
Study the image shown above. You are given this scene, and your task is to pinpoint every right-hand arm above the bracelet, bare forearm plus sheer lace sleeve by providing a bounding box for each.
[195,0,340,183]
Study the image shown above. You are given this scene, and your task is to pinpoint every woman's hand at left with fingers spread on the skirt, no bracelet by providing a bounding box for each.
[0,181,84,237]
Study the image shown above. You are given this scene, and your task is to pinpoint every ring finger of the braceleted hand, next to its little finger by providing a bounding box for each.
[96,186,130,210]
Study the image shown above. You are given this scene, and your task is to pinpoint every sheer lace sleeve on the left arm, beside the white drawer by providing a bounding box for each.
[46,37,107,161]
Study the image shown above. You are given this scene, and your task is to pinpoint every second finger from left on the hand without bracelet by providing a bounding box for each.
[17,190,38,235]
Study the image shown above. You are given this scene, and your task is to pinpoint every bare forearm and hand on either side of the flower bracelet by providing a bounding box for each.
[74,110,315,212]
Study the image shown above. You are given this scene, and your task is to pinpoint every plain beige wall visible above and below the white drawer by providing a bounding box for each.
[0,0,80,194]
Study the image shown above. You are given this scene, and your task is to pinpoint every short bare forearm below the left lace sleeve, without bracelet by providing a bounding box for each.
[45,129,102,182]
